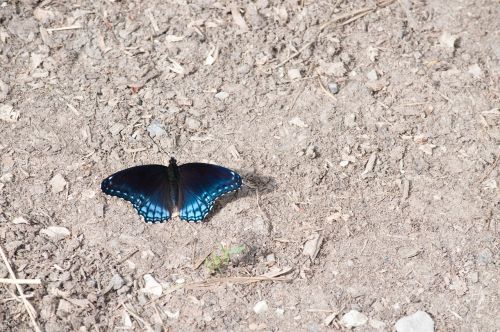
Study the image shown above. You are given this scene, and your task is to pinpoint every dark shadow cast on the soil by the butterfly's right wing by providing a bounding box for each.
[204,172,278,221]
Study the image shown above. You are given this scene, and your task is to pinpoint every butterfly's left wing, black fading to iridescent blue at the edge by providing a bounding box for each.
[101,165,172,223]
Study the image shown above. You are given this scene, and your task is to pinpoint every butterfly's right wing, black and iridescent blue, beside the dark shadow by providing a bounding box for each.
[178,163,241,221]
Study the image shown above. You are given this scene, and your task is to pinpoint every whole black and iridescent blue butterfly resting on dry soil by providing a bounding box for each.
[101,158,241,223]
